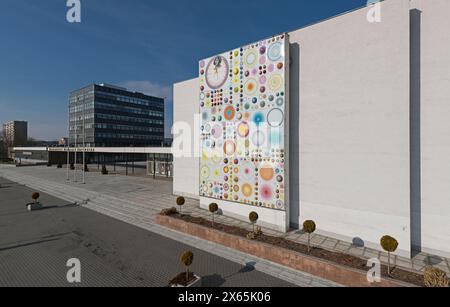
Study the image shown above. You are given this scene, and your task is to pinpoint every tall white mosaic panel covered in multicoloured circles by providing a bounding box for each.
[199,35,289,210]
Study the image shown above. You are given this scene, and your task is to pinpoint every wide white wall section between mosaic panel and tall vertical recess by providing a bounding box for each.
[291,0,411,256]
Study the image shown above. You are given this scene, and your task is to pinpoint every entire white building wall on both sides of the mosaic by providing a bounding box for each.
[174,0,450,256]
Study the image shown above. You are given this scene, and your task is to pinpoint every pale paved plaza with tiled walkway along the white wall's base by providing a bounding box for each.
[0,166,450,278]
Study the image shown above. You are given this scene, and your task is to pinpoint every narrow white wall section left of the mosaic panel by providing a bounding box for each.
[173,78,200,199]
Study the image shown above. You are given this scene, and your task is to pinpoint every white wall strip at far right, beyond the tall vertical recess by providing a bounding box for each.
[411,0,450,256]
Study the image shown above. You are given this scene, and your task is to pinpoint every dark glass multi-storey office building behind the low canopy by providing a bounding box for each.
[69,84,164,147]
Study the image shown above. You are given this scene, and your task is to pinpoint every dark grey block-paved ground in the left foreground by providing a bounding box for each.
[0,178,293,287]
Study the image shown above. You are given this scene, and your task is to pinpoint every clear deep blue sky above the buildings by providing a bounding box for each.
[0,0,367,140]
